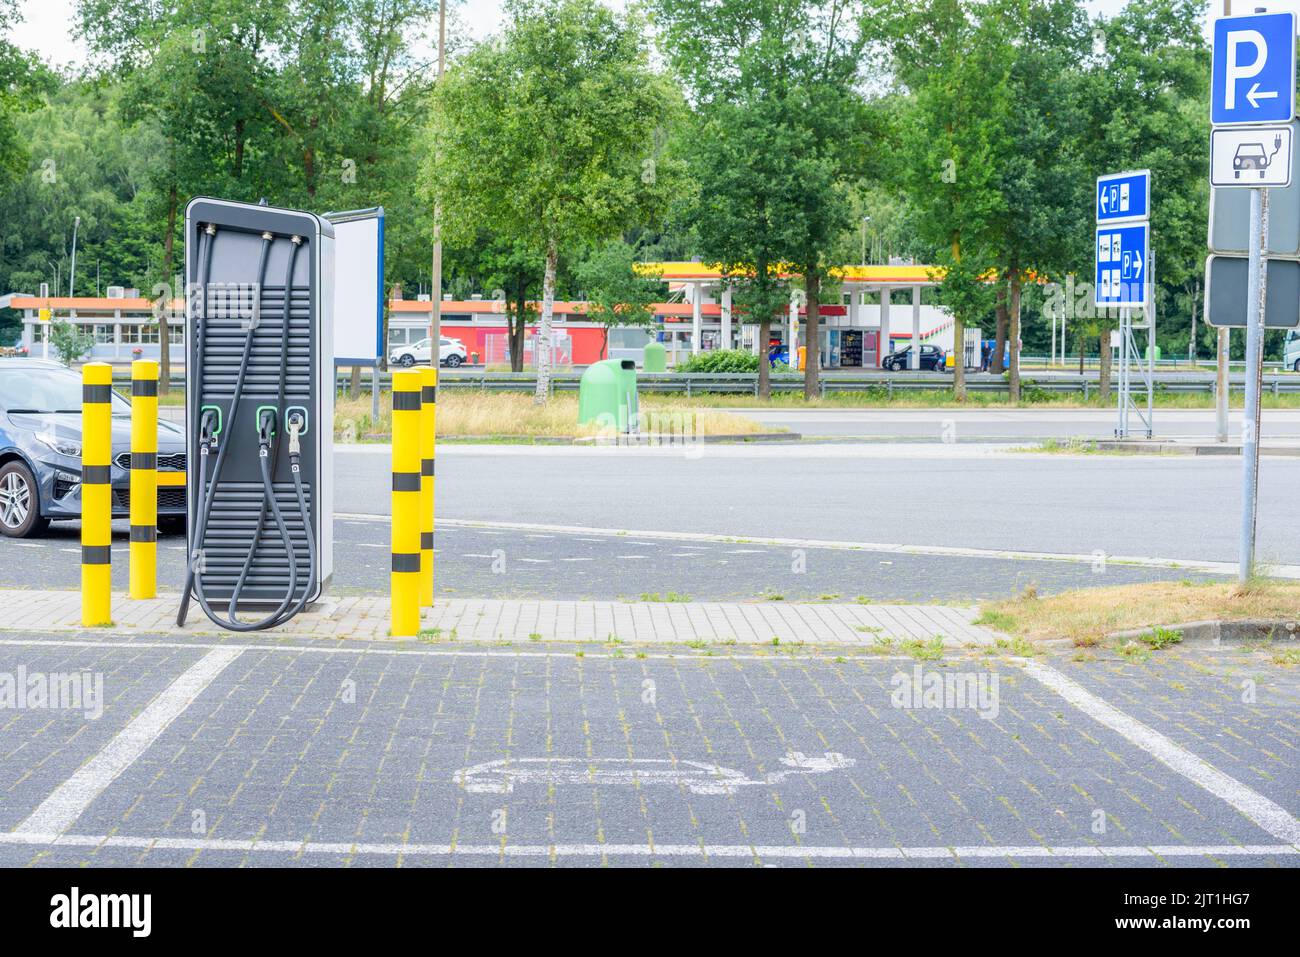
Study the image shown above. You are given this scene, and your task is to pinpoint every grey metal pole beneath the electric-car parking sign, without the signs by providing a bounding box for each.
[1238,183,1269,583]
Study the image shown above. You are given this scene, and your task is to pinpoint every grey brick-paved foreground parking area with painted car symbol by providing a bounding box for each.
[0,633,1300,867]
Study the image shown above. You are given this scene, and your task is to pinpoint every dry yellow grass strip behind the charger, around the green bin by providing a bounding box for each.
[334,389,772,441]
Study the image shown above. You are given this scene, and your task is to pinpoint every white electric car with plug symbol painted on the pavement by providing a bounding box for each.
[451,752,857,794]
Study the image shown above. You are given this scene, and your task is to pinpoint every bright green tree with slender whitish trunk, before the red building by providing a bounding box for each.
[428,0,679,403]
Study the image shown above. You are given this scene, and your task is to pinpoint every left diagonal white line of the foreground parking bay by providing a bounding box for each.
[14,648,243,835]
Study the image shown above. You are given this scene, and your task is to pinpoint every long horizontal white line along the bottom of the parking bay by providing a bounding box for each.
[0,832,1300,861]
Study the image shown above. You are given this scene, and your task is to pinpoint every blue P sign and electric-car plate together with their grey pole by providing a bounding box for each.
[1210,12,1296,581]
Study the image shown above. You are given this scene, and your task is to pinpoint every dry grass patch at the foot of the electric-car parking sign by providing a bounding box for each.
[976,580,1300,645]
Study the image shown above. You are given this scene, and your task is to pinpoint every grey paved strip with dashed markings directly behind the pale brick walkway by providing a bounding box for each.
[0,515,1213,602]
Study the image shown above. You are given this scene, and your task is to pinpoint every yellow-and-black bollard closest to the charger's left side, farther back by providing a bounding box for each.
[130,359,159,598]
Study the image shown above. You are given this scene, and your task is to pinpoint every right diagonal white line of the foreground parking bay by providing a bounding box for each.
[1023,661,1300,844]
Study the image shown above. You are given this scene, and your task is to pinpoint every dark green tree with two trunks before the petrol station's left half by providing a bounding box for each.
[653,0,866,398]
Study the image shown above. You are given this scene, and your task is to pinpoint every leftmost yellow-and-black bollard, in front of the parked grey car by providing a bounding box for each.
[82,363,113,627]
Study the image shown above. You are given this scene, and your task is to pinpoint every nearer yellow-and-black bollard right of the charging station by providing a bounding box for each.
[390,369,424,638]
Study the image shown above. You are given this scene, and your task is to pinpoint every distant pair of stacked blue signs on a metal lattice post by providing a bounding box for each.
[1092,169,1156,438]
